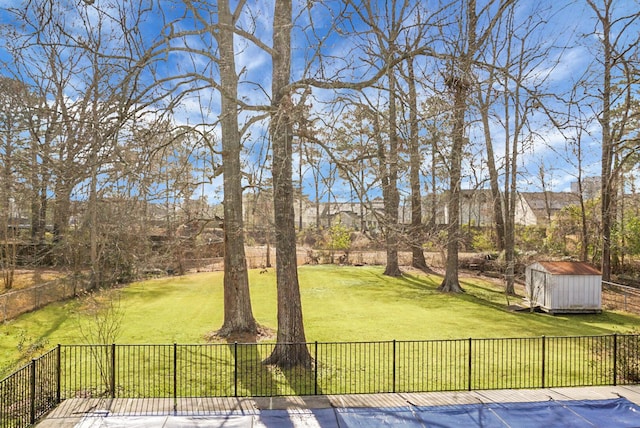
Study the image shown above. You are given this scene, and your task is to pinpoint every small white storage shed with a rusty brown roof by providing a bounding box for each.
[525,262,602,314]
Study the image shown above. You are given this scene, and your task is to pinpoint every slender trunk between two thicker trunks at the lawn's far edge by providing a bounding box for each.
[407,58,429,270]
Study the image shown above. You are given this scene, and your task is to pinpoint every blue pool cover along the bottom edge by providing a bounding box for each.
[76,398,640,428]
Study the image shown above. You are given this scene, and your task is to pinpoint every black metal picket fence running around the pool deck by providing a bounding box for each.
[0,335,640,428]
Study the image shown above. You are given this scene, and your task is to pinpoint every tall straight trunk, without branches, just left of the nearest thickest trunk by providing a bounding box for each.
[217,0,258,337]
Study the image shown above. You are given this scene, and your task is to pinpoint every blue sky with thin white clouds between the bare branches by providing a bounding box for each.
[0,0,640,202]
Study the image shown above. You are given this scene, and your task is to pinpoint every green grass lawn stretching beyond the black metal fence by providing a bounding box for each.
[0,265,640,375]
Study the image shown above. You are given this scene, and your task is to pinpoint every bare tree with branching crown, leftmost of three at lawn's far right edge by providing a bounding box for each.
[333,0,430,276]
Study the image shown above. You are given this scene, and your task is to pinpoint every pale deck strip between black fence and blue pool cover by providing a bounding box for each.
[37,385,640,428]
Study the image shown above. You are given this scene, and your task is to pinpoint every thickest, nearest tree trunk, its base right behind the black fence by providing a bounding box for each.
[264,0,312,368]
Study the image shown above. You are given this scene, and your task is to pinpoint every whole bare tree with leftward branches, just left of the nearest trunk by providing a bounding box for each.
[158,0,266,337]
